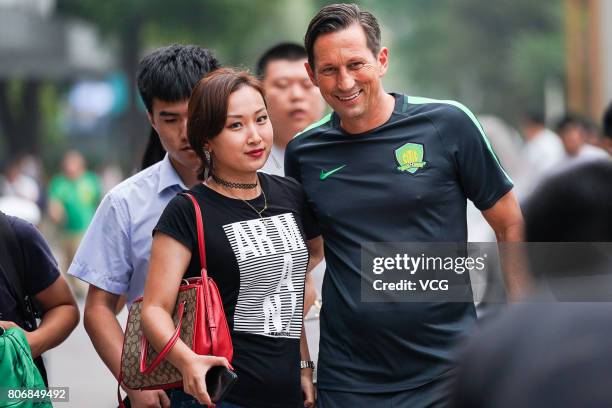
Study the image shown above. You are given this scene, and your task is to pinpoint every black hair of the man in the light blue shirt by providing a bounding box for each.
[136,44,220,113]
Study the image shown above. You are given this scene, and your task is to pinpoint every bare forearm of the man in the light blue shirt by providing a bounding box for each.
[83,305,123,379]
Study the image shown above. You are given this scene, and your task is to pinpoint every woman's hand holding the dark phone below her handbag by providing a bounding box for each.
[180,354,232,405]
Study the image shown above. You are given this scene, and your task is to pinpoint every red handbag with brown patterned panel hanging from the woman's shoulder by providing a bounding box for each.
[117,193,234,408]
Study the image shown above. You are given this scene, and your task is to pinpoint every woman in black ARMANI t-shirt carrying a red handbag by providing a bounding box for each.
[142,68,322,408]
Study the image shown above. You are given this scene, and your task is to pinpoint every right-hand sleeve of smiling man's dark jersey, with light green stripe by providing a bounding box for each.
[436,103,513,211]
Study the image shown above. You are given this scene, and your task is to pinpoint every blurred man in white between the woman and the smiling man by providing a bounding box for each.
[257,43,325,370]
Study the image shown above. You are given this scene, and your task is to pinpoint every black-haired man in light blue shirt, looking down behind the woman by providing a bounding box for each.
[68,45,219,407]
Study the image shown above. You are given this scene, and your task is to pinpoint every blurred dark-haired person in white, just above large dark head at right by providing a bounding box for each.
[556,114,610,165]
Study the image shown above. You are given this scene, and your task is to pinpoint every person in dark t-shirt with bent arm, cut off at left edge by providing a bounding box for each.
[0,212,79,388]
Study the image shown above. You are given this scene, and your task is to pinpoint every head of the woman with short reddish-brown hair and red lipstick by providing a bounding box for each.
[187,68,272,184]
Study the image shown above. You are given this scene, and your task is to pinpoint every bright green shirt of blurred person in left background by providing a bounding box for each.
[49,171,101,234]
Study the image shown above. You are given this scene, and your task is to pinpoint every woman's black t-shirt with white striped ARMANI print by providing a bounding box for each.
[154,173,319,408]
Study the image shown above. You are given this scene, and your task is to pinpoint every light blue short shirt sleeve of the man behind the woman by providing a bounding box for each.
[68,194,133,295]
